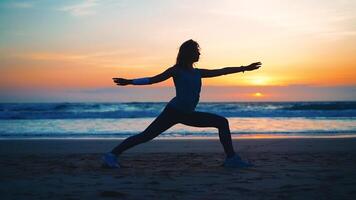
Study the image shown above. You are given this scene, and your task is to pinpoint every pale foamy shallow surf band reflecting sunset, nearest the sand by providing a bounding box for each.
[0,117,356,139]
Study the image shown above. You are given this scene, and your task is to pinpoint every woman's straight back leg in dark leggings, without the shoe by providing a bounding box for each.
[111,109,176,156]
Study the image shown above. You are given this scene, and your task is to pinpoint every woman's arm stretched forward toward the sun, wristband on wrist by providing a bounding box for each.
[199,62,262,78]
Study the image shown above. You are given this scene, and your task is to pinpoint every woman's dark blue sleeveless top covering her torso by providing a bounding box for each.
[168,67,201,112]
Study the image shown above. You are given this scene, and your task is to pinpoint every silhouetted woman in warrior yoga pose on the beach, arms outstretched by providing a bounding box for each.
[103,40,261,168]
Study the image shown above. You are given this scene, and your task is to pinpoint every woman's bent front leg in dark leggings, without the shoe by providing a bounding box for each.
[180,111,235,157]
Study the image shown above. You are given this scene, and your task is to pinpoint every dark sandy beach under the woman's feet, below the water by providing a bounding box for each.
[0,138,356,200]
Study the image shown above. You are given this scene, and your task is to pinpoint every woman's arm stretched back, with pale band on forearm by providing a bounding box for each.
[113,67,175,86]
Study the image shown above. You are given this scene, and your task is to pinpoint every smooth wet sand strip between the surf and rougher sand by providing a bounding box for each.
[0,137,356,155]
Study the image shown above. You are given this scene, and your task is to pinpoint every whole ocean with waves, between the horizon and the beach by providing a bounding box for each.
[0,102,356,139]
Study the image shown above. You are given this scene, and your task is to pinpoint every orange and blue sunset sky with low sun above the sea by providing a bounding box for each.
[0,0,356,102]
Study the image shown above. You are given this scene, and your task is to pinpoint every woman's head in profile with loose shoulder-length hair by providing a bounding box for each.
[176,40,199,66]
